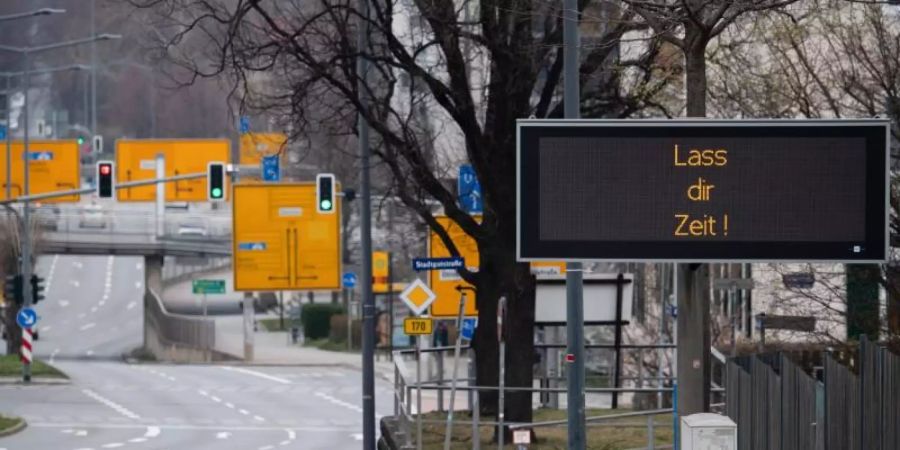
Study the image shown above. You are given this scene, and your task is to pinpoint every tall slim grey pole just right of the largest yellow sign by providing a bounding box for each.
[356,0,375,450]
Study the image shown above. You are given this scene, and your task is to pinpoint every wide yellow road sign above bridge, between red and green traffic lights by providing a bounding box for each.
[116,139,231,202]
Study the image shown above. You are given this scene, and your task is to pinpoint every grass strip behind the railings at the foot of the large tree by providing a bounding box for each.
[413,409,673,450]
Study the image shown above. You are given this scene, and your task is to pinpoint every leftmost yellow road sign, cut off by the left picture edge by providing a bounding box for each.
[0,140,81,203]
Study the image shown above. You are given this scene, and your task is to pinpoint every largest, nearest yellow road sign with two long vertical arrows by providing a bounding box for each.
[232,183,341,291]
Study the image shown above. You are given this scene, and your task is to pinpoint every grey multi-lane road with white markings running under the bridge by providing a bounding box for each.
[0,256,391,450]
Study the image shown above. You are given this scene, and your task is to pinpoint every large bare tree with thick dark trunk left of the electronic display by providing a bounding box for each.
[134,0,672,428]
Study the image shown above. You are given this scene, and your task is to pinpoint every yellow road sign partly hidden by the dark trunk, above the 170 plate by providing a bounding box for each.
[428,216,481,317]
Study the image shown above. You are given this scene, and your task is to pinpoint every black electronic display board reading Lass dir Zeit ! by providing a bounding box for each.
[517,119,890,262]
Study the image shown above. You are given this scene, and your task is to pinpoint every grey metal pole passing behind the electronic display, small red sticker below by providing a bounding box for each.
[563,0,585,450]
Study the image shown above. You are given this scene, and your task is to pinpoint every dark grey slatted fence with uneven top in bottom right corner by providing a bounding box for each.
[726,338,900,450]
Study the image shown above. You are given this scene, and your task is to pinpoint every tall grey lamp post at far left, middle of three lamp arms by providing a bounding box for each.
[0,34,121,381]
